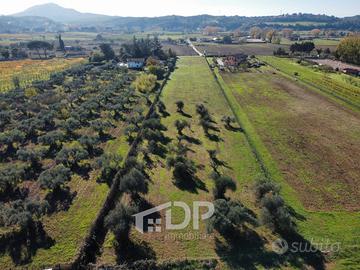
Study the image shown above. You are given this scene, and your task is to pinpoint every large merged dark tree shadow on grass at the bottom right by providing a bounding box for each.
[215,220,325,270]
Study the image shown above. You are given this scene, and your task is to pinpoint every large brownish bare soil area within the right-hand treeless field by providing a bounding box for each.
[228,70,360,211]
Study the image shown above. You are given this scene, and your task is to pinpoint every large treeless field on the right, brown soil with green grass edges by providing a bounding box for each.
[214,62,360,269]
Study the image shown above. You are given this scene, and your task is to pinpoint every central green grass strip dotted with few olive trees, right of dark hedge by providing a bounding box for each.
[101,57,268,267]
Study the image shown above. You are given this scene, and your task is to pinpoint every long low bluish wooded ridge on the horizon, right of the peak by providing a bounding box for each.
[93,13,360,32]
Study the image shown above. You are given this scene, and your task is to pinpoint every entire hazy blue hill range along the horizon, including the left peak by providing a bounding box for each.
[4,3,360,32]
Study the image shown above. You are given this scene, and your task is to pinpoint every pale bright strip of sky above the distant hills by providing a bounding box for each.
[0,0,360,17]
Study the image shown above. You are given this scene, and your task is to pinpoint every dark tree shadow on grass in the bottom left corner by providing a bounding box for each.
[0,222,55,265]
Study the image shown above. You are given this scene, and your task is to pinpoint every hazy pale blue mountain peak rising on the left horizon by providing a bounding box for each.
[12,3,111,23]
